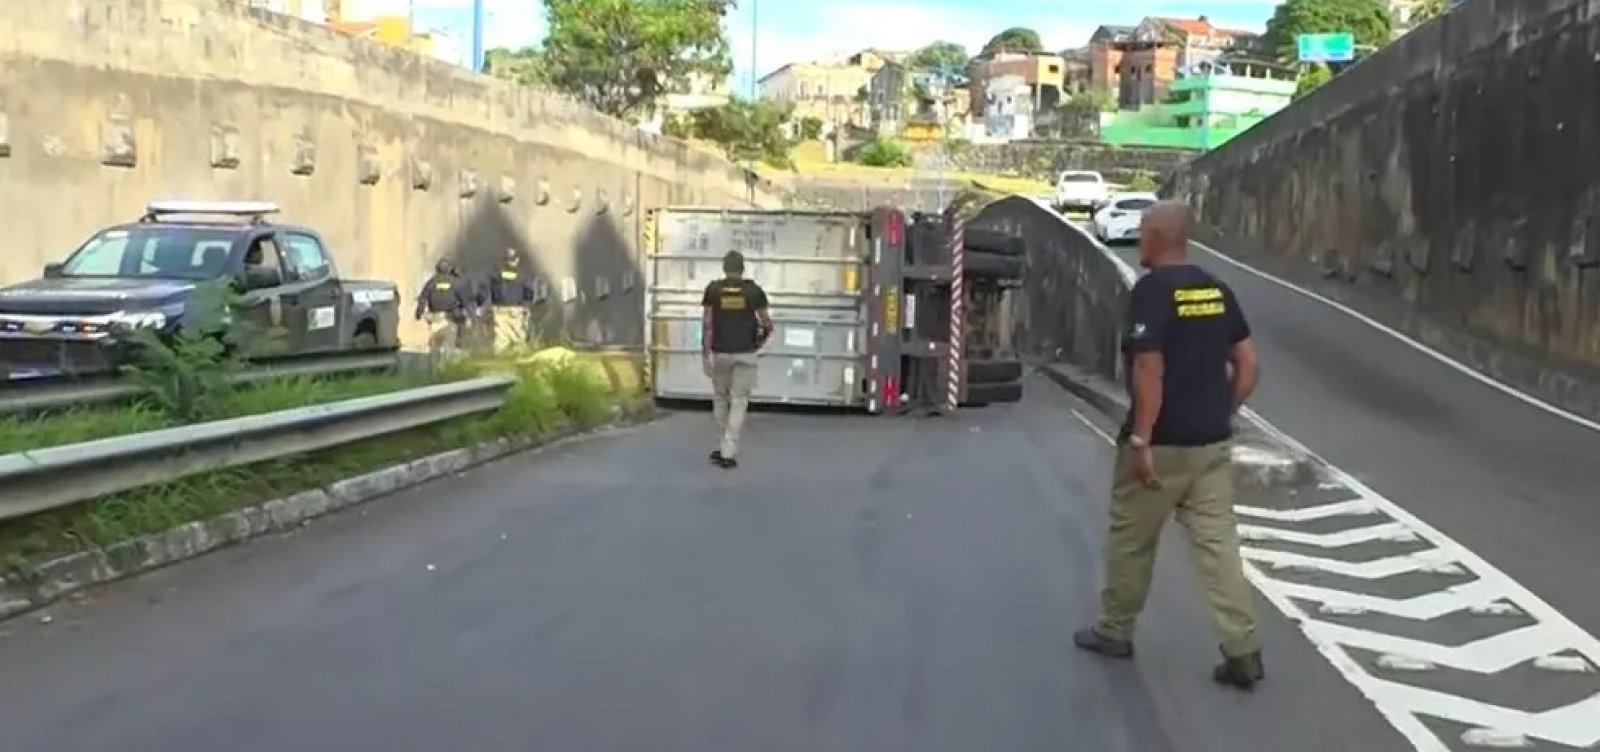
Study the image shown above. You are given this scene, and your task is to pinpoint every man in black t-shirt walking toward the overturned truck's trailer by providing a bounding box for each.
[701,251,773,469]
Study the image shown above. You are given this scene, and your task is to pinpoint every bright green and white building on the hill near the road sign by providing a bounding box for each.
[1101,59,1296,150]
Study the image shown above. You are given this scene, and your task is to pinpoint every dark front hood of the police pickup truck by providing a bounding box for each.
[0,277,194,315]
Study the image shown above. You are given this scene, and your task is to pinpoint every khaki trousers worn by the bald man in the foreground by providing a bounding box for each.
[1094,442,1258,656]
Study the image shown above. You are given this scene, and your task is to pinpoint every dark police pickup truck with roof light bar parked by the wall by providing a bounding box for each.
[0,202,400,379]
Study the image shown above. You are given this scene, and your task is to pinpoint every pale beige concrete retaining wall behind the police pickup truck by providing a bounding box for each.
[0,0,778,344]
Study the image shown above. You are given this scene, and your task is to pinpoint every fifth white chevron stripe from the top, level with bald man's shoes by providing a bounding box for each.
[1301,621,1580,675]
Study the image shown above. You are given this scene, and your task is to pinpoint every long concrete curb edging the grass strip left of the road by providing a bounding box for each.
[0,408,658,621]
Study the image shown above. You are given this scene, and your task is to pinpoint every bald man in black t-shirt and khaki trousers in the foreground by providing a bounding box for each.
[1074,202,1266,690]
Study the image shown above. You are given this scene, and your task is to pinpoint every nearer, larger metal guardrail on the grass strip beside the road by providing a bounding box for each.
[0,376,515,520]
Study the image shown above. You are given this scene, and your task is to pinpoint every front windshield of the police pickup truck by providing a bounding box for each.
[59,224,238,280]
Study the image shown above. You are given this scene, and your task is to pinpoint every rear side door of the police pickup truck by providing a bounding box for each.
[277,230,350,352]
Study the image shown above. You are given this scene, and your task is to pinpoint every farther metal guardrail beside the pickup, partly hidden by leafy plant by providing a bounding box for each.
[0,350,402,414]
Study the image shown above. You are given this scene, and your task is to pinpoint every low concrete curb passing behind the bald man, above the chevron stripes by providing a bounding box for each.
[1037,363,1328,488]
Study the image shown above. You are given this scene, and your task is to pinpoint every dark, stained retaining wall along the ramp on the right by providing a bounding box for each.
[1171,0,1600,411]
